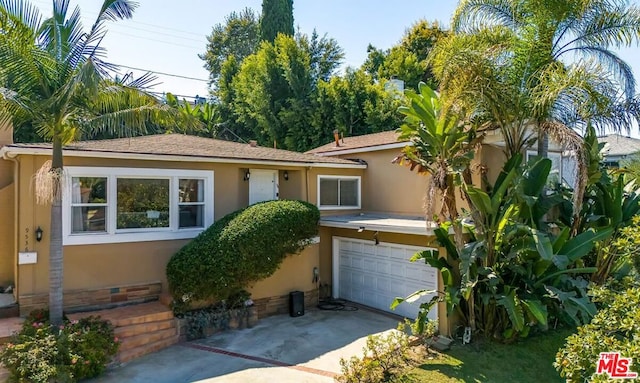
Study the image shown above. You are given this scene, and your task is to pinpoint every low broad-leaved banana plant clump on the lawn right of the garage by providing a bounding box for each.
[394,152,612,340]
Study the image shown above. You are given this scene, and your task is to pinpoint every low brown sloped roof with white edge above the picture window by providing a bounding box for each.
[0,134,363,167]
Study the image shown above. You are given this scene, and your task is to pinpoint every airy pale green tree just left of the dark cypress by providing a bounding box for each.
[198,8,260,92]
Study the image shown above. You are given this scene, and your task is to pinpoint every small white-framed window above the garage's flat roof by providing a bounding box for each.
[318,175,361,210]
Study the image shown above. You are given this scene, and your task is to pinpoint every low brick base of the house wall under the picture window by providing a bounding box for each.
[18,282,162,316]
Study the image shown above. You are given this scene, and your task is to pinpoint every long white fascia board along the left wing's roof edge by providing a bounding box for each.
[0,146,367,169]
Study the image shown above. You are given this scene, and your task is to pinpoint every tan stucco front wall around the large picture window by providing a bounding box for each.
[14,155,330,295]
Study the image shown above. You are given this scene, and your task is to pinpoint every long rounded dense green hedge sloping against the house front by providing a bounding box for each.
[167,200,320,311]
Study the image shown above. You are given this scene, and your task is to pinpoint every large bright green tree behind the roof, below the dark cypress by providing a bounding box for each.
[230,35,342,151]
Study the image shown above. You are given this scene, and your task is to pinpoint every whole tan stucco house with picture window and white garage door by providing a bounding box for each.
[0,123,576,333]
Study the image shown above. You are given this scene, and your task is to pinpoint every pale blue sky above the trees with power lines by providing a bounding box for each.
[33,0,640,103]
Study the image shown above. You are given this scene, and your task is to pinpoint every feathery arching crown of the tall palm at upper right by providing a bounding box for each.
[452,0,640,156]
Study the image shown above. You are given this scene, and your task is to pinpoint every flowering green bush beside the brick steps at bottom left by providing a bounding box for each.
[0,310,118,383]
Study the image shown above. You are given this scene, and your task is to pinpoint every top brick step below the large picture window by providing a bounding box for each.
[68,302,173,327]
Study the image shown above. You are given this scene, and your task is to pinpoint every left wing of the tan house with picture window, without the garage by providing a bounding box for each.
[0,130,366,315]
